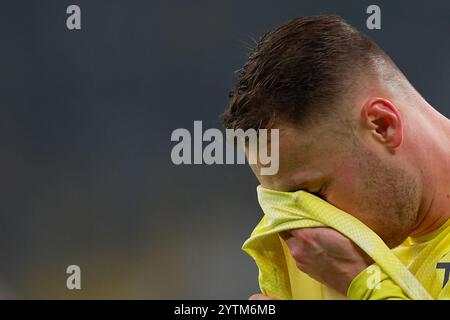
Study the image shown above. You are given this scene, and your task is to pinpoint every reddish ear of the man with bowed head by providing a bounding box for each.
[361,98,403,149]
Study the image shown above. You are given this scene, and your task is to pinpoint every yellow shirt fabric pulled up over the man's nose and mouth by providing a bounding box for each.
[242,186,432,300]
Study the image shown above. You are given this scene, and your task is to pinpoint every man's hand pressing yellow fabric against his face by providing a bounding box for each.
[280,228,373,295]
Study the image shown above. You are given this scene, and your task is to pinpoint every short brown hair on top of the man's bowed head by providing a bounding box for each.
[223,15,393,130]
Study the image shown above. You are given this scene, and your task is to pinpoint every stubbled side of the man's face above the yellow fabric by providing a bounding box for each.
[252,121,420,248]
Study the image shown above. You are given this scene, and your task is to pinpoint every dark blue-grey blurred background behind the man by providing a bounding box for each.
[0,0,450,299]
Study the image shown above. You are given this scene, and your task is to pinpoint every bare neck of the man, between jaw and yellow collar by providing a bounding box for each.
[410,104,450,237]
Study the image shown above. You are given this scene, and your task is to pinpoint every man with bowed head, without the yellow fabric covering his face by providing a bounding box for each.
[224,16,450,300]
